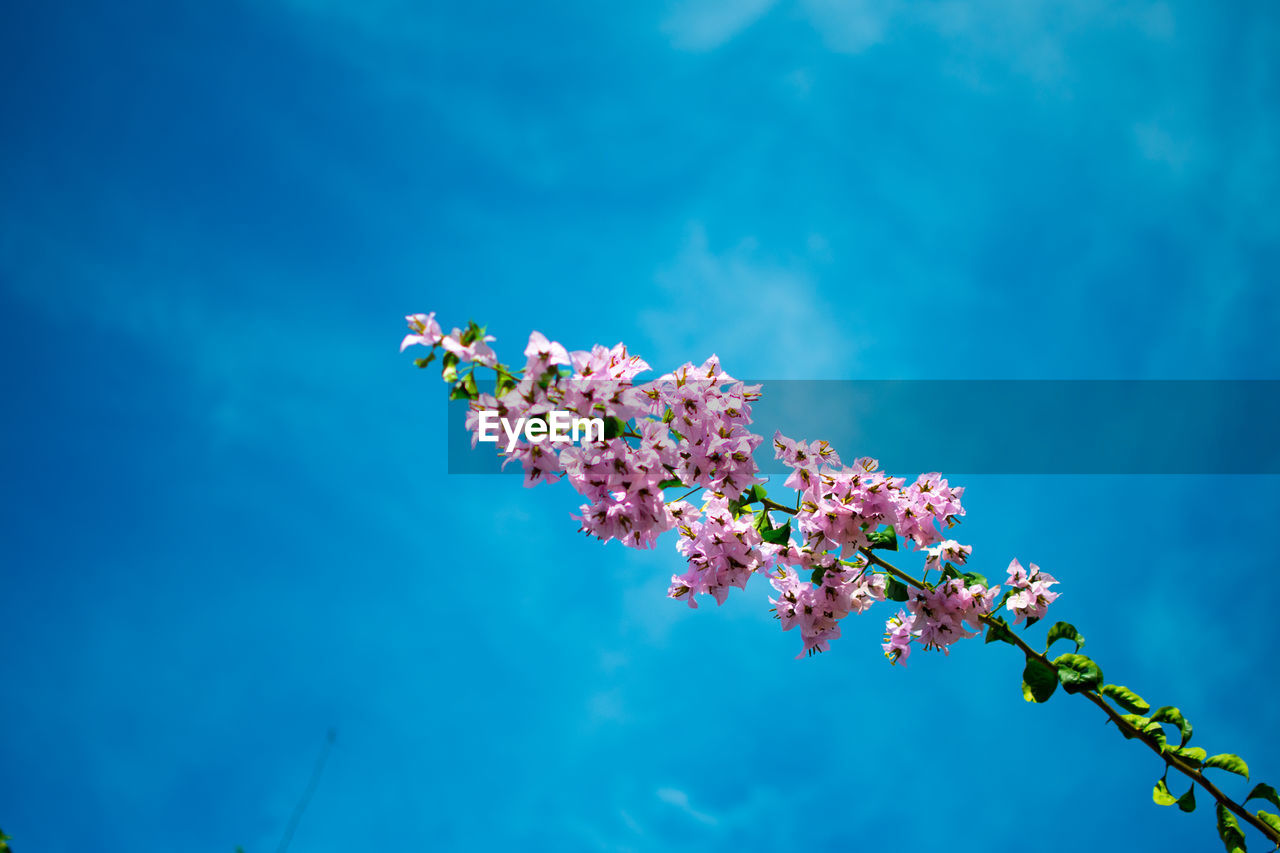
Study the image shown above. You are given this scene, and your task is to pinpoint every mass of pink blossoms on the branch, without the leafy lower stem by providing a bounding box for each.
[401,314,1057,662]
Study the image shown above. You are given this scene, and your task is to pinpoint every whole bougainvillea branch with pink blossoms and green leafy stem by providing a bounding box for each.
[401,314,1280,852]
